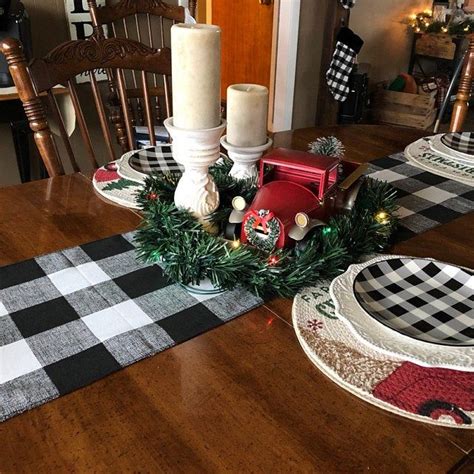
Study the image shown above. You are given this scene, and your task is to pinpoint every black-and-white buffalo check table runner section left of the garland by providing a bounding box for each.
[0,234,262,421]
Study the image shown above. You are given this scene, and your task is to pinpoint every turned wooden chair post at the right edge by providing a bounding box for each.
[449,34,474,132]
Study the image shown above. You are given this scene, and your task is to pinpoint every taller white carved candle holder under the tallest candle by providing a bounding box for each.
[164,117,226,219]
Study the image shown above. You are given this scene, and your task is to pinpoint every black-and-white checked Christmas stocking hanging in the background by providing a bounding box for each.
[326,28,364,102]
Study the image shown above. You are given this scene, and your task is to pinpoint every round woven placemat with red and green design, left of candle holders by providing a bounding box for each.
[92,155,143,209]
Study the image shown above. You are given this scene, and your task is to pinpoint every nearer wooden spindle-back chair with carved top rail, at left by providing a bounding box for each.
[0,35,171,176]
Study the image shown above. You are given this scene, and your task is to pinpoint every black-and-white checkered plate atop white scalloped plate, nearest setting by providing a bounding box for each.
[354,258,474,346]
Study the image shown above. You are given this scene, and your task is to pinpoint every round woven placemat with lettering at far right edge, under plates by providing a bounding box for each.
[405,137,474,186]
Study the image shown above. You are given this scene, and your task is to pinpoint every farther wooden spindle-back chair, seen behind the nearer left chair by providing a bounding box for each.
[88,0,190,152]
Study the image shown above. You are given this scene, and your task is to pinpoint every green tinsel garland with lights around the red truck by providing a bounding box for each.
[135,160,397,297]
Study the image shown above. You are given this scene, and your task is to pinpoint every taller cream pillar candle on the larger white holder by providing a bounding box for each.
[171,23,221,130]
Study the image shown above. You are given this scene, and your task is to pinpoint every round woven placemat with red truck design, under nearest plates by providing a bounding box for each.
[292,281,474,429]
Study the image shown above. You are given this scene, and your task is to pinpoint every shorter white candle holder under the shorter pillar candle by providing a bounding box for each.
[221,135,273,180]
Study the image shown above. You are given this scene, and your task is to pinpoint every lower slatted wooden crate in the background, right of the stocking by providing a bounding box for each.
[372,90,437,130]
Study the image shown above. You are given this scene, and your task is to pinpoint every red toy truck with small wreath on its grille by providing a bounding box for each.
[226,148,365,252]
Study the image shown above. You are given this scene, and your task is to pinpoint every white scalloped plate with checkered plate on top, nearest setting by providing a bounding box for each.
[330,256,474,371]
